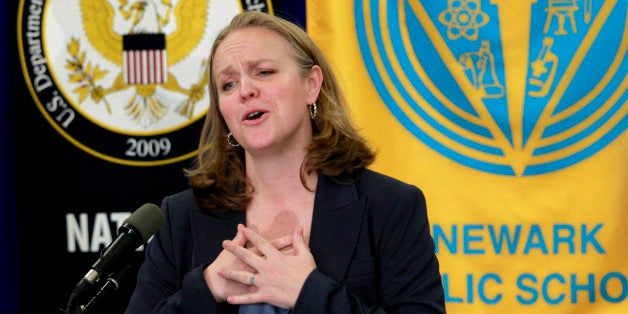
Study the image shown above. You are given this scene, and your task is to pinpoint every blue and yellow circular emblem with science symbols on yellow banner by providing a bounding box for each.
[354,0,628,176]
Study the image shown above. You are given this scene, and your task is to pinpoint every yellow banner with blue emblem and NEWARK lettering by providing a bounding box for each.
[306,0,628,313]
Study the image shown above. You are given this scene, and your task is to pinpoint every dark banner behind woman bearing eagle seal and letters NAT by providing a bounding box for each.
[0,0,305,313]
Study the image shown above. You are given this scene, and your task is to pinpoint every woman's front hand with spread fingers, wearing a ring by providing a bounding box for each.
[218,228,316,309]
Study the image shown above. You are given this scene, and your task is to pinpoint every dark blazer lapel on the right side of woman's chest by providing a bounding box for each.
[310,175,364,282]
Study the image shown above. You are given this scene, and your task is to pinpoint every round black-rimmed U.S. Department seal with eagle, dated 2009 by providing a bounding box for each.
[18,0,272,166]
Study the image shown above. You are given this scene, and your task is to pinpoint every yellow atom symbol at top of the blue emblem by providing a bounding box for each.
[438,0,489,40]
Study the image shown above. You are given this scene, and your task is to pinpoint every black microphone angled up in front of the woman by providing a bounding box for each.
[68,203,164,312]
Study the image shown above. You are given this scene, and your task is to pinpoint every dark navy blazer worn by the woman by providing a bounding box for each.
[127,170,445,313]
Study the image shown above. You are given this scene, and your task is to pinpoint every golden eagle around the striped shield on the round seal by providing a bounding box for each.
[74,0,209,126]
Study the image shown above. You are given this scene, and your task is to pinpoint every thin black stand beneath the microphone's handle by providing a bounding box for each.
[65,265,131,314]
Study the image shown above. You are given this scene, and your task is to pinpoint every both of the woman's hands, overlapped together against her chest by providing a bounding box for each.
[204,225,316,309]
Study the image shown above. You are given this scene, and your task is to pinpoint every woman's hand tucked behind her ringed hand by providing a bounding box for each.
[203,224,292,303]
